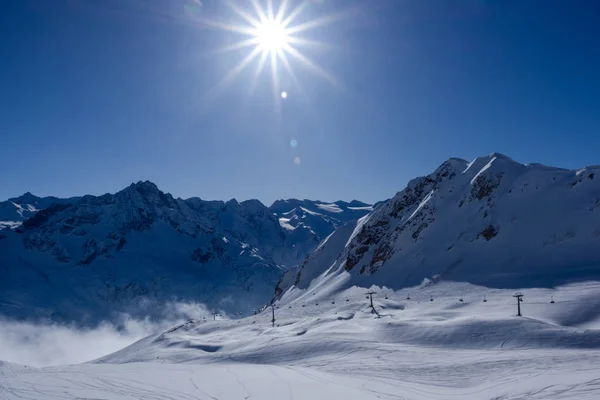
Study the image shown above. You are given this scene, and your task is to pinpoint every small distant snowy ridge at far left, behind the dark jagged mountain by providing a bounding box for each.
[0,192,76,230]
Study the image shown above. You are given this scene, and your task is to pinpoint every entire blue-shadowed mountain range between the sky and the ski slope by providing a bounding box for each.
[7,153,600,323]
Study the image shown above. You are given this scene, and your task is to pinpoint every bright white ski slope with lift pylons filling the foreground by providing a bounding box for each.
[0,282,600,400]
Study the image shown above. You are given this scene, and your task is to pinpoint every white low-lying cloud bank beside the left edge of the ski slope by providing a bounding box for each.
[0,303,216,367]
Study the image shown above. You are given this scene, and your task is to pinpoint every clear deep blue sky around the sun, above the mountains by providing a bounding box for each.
[0,0,600,203]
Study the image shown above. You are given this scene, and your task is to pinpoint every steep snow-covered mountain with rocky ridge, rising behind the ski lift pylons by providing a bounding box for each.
[276,153,600,296]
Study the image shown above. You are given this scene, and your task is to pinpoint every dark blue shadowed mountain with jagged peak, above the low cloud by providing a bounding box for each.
[0,182,370,322]
